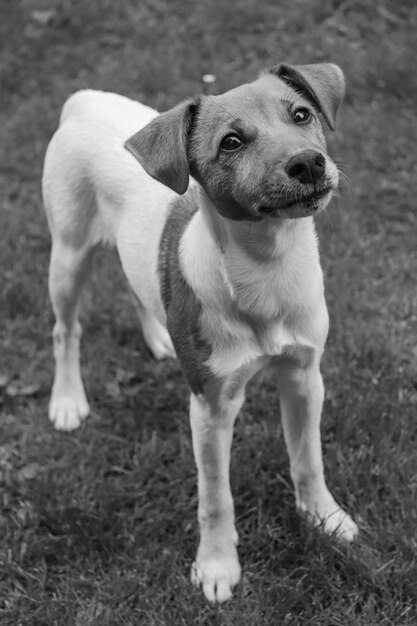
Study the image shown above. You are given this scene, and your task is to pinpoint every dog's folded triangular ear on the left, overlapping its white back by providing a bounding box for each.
[125,98,199,194]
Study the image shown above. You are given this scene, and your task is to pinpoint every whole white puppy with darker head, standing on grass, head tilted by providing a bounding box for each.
[43,63,357,602]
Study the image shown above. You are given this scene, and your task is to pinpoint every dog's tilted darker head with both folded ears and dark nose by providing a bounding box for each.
[125,63,344,220]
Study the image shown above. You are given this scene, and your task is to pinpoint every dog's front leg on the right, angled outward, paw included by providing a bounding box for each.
[279,362,358,541]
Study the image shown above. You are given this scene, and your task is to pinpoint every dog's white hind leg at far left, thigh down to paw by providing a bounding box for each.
[49,237,92,431]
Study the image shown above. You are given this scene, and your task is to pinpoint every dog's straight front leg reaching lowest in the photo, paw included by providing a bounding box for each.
[190,392,243,602]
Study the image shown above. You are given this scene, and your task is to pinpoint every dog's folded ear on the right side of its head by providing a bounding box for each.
[268,63,345,130]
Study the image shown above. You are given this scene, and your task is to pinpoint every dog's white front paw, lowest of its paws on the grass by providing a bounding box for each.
[191,550,240,603]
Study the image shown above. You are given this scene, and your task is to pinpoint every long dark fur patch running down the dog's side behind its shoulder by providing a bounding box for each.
[158,190,211,393]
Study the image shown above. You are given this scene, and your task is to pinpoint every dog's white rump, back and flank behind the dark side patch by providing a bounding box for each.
[42,90,176,316]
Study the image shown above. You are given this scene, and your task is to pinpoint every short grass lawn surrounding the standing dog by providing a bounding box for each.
[0,0,417,626]
